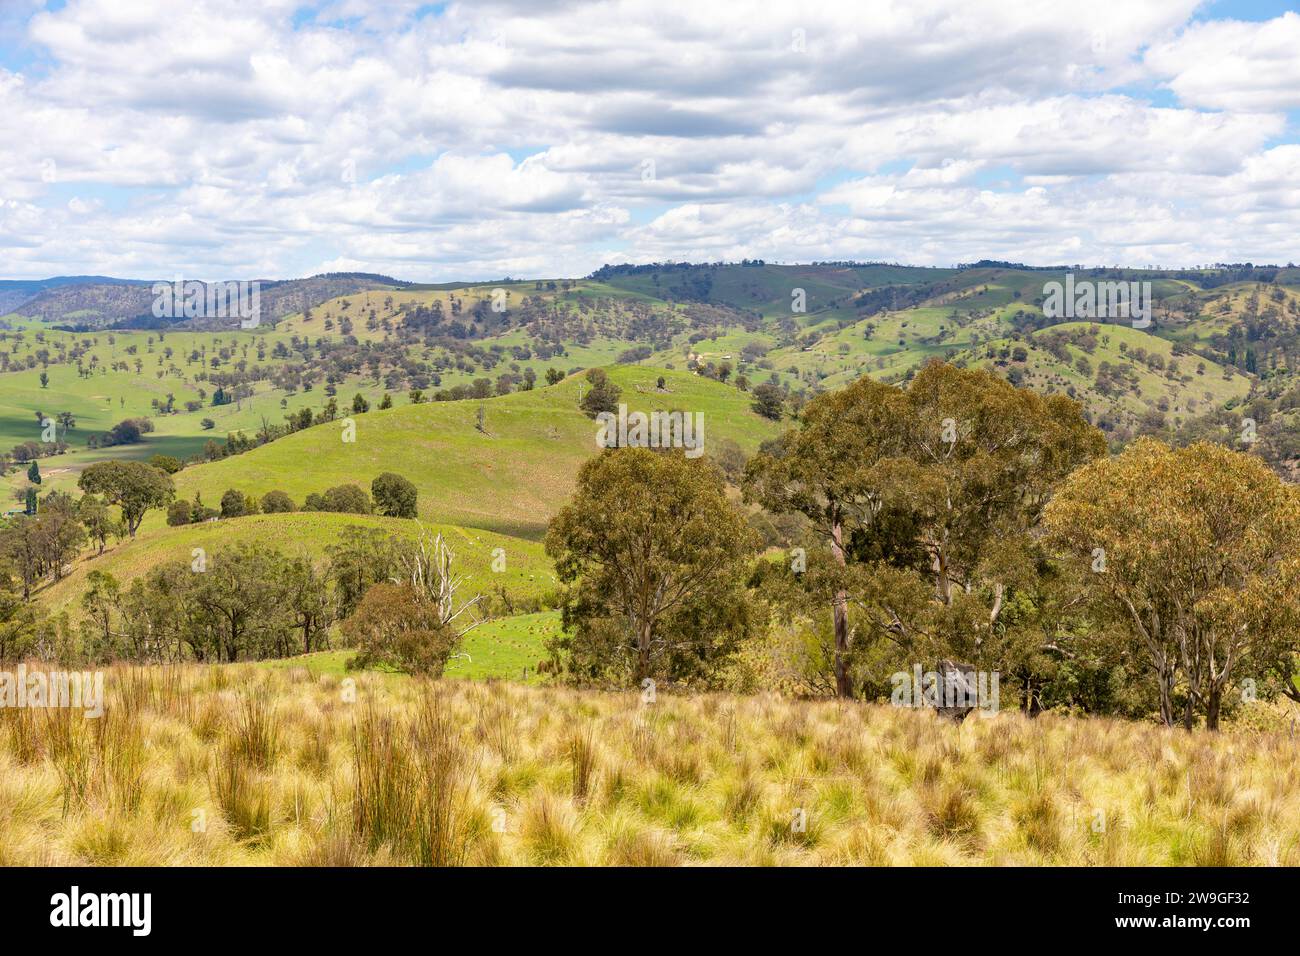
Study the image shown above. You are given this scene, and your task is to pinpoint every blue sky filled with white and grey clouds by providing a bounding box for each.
[0,0,1300,281]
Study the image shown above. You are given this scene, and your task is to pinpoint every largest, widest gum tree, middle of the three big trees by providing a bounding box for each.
[745,362,1105,696]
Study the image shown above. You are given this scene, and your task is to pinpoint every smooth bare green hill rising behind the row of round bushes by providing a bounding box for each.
[165,365,780,540]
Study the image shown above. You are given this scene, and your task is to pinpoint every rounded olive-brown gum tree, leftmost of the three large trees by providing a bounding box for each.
[546,447,755,682]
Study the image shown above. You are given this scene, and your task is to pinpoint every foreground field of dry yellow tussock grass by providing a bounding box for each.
[0,666,1300,866]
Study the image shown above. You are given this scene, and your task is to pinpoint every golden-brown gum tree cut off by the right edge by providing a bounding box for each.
[1045,438,1300,730]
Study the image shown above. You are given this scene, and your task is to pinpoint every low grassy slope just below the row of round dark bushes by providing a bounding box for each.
[36,512,556,613]
